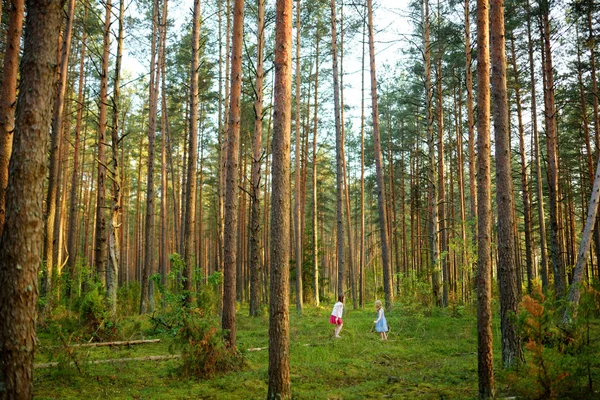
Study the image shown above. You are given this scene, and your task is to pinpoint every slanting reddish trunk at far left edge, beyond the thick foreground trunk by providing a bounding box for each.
[0,0,25,235]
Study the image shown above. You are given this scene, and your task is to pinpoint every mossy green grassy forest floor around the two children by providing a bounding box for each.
[29,304,584,399]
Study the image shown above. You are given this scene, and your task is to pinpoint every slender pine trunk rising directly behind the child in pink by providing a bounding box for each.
[330,0,345,296]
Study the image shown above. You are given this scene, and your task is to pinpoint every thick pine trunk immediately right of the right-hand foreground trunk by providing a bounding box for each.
[490,0,523,368]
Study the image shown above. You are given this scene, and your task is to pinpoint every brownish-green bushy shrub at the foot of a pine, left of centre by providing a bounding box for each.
[174,310,244,379]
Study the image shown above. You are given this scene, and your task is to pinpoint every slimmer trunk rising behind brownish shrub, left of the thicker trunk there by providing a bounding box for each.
[182,0,202,305]
